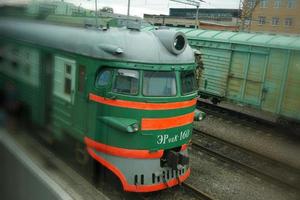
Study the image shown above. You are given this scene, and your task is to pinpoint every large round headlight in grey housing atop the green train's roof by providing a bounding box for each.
[154,30,187,55]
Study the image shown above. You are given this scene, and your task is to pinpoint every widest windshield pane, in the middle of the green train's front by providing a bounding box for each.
[143,71,177,97]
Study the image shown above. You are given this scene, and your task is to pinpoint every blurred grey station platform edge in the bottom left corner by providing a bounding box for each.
[0,128,109,200]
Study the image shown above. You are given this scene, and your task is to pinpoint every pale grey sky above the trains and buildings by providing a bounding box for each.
[0,0,239,16]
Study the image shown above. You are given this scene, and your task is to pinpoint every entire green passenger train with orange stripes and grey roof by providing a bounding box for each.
[0,19,203,192]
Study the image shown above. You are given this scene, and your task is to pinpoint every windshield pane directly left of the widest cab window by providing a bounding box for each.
[113,69,139,95]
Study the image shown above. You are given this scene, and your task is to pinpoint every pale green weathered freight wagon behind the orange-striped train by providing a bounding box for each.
[159,29,300,122]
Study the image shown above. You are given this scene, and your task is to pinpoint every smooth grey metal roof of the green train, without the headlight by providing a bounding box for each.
[0,19,194,64]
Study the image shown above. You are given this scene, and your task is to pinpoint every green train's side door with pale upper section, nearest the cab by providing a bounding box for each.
[53,56,87,138]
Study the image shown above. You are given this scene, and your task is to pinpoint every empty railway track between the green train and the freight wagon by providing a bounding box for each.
[192,129,300,190]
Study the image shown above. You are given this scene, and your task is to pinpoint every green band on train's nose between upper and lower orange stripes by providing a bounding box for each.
[87,100,195,150]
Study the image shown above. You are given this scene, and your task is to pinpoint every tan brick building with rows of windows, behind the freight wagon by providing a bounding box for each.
[248,0,300,34]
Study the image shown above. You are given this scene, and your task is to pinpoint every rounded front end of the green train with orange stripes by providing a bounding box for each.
[84,28,200,192]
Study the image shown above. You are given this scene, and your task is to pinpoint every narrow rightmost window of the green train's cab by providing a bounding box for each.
[180,70,197,94]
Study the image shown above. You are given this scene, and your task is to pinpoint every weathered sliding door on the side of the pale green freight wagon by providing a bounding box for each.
[227,48,267,106]
